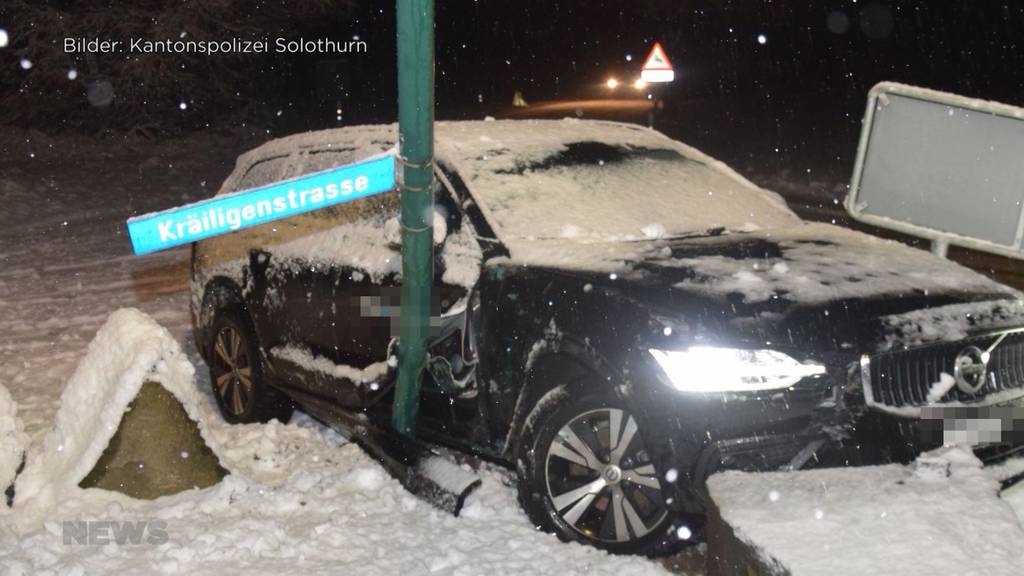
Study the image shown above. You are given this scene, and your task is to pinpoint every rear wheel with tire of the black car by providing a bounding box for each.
[207,305,293,424]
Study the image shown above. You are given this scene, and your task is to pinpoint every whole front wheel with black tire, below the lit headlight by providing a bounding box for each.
[516,386,673,554]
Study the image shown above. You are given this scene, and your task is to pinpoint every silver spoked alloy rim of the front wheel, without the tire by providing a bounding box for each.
[545,408,668,543]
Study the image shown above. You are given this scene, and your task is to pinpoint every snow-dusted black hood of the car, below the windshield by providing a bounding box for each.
[483,219,1024,304]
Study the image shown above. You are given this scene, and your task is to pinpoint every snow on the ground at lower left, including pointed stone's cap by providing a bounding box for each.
[0,310,663,576]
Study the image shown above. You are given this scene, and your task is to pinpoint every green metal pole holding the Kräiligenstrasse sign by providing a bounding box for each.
[392,0,434,436]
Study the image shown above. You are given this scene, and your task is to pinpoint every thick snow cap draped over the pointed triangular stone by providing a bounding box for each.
[13,308,218,528]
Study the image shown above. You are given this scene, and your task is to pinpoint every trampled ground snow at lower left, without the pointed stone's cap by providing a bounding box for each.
[0,383,666,576]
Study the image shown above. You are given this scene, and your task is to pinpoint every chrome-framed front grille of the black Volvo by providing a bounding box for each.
[861,330,1024,409]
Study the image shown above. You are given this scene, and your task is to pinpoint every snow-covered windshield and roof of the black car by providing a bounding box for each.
[225,119,800,241]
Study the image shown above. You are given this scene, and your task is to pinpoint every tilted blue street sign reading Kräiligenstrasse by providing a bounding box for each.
[128,155,394,254]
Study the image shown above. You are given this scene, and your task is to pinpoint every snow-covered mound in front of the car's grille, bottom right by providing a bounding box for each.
[708,448,1024,576]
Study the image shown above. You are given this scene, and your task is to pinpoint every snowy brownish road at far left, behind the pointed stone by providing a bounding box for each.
[0,135,222,436]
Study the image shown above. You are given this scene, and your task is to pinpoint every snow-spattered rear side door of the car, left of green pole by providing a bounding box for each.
[251,147,400,404]
